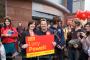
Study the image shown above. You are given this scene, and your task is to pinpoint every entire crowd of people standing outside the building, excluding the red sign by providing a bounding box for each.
[0,16,90,60]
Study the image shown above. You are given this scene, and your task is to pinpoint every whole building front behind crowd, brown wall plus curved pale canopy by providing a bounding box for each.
[0,0,70,26]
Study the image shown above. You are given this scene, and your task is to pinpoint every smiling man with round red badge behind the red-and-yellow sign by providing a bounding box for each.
[37,18,53,60]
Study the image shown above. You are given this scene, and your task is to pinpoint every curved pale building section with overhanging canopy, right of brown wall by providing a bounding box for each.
[32,0,69,20]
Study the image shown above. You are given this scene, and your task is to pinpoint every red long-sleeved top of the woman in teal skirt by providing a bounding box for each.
[1,27,18,43]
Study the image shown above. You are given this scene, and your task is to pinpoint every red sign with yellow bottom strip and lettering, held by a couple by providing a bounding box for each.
[26,35,54,58]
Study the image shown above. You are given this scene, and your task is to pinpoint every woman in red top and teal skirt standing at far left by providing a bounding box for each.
[1,17,18,60]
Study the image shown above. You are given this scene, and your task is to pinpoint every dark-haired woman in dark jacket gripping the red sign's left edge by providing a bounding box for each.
[20,21,37,60]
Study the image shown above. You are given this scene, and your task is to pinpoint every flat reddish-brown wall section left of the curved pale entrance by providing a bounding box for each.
[6,0,32,26]
